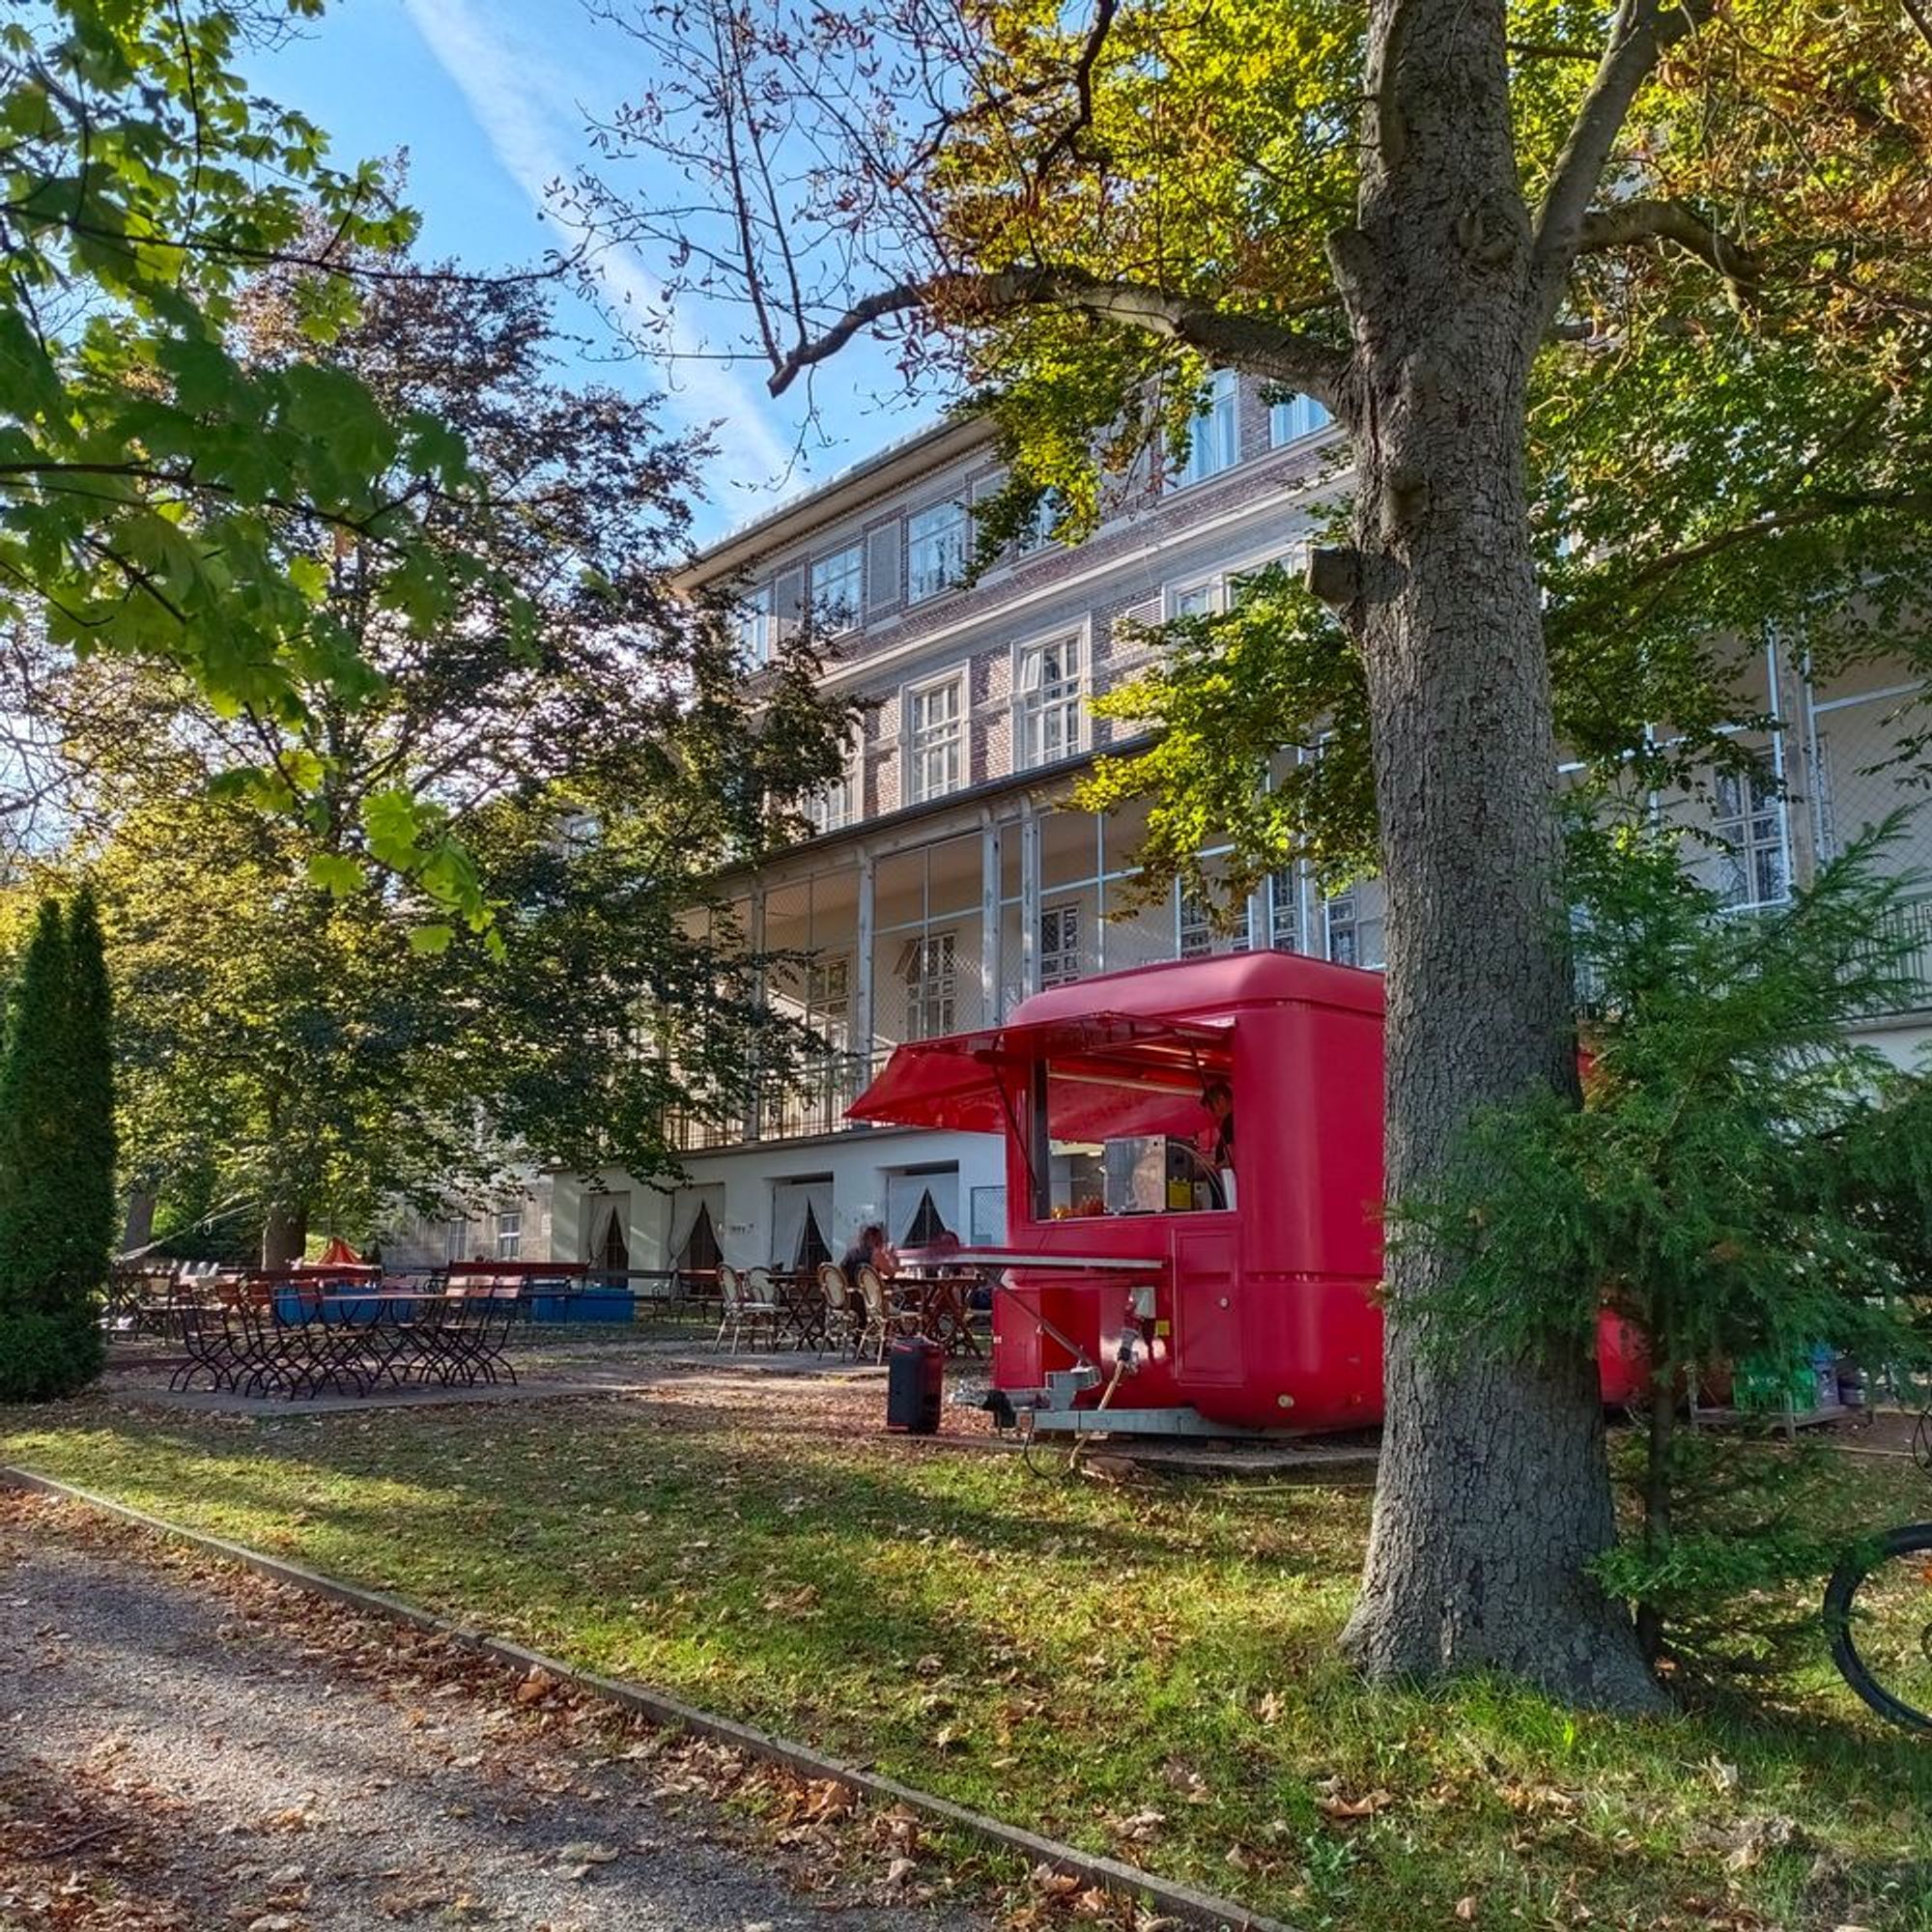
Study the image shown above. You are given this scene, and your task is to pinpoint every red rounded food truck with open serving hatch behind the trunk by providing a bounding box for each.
[850,952,1634,1435]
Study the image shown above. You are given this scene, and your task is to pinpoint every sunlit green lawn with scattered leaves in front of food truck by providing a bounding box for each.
[0,1397,1932,1932]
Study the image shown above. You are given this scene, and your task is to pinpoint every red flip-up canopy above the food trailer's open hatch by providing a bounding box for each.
[846,1012,1233,1138]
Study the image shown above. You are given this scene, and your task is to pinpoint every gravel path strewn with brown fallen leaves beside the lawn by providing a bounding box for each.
[0,1499,985,1932]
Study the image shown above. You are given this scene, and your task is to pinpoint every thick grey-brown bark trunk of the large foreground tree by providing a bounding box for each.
[1335,0,1658,1706]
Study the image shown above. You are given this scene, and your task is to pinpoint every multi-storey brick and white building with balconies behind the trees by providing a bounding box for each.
[415,373,1932,1267]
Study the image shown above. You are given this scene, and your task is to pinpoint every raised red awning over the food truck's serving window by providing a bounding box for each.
[846,1012,1233,1134]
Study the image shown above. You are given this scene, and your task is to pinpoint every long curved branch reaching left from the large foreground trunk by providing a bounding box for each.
[769,269,1349,415]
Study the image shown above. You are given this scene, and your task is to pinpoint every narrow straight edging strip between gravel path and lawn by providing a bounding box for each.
[0,1463,1294,1932]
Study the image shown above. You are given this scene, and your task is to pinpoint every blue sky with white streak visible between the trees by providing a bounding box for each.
[249,0,929,537]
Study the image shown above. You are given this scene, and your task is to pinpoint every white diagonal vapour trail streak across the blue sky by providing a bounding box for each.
[404,0,790,487]
